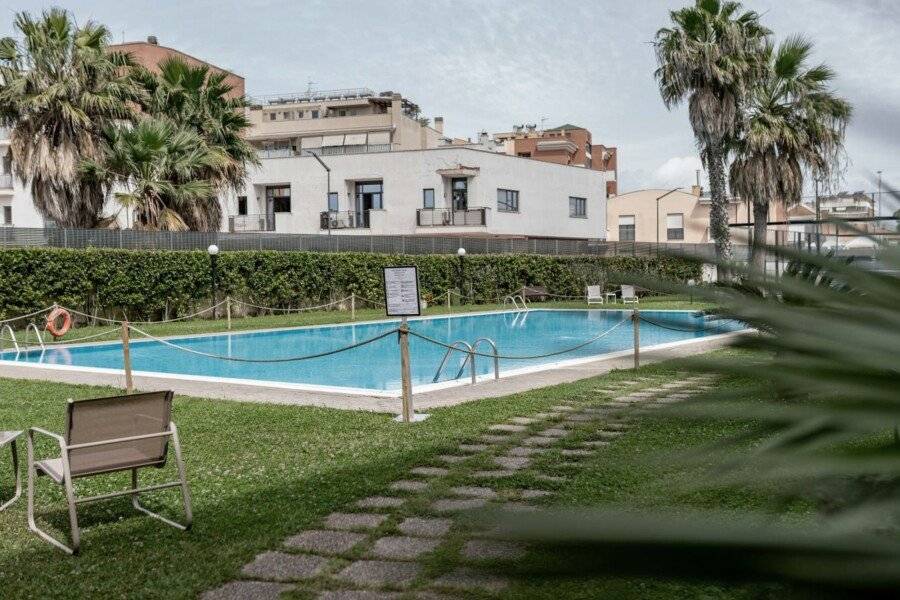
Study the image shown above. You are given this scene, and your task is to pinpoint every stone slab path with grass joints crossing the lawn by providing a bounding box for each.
[202,375,714,600]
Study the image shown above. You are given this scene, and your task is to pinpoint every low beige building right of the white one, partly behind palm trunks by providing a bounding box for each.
[606,186,785,244]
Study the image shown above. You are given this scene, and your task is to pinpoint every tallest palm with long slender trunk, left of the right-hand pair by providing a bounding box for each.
[654,0,770,268]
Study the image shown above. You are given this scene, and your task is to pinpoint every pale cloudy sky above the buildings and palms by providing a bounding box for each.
[0,0,900,216]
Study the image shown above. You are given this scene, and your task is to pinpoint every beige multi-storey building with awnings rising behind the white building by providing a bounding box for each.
[247,88,443,158]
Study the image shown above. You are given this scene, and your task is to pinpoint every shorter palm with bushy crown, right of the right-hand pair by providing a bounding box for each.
[730,36,852,272]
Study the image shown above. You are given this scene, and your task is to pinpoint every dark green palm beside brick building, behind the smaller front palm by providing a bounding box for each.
[133,57,259,230]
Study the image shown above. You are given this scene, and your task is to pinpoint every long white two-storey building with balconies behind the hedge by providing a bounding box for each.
[226,144,606,239]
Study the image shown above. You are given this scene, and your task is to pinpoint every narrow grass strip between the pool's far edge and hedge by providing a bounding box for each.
[0,295,712,349]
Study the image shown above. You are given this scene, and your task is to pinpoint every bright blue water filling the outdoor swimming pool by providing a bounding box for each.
[0,309,742,391]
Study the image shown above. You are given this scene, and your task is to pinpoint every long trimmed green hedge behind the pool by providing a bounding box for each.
[0,248,700,319]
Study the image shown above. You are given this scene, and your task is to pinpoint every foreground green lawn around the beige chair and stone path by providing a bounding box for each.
[0,352,800,599]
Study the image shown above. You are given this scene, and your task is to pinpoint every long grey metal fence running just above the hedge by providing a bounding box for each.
[0,227,747,260]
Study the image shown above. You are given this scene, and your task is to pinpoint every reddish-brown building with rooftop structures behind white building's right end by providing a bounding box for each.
[494,123,618,195]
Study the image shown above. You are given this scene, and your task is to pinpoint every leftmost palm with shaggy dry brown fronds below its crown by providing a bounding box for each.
[0,8,139,227]
